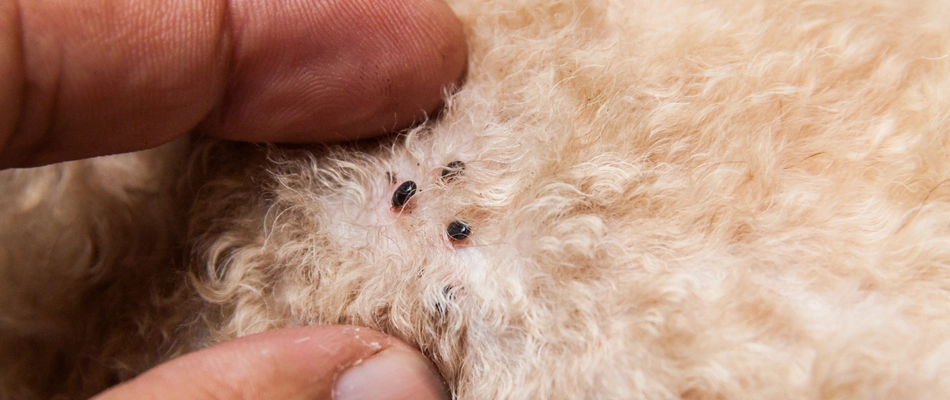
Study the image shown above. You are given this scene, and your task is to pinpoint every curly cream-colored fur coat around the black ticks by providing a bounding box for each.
[0,0,950,399]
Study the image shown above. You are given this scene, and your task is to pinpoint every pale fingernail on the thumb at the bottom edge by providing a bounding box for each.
[333,348,449,400]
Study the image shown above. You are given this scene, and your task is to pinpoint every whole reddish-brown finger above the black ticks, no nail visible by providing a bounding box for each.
[0,0,465,167]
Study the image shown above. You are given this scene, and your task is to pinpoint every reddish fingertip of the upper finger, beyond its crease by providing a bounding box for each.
[201,0,467,142]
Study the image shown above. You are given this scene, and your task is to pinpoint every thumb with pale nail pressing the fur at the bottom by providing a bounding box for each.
[96,326,448,400]
